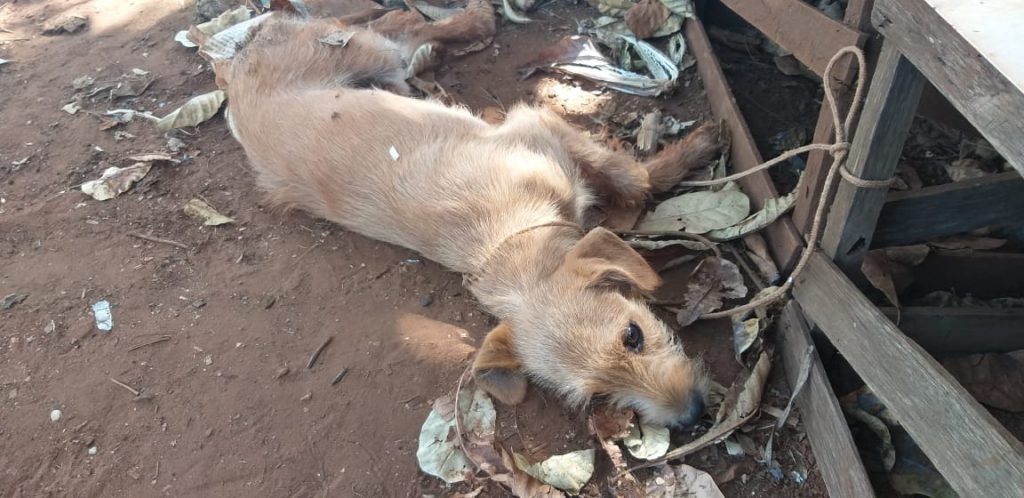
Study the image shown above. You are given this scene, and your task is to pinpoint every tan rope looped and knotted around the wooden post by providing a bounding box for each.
[679,46,880,320]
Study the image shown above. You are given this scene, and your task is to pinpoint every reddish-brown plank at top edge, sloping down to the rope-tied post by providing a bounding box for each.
[722,0,865,76]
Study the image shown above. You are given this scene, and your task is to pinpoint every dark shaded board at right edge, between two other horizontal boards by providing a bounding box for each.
[904,251,1024,299]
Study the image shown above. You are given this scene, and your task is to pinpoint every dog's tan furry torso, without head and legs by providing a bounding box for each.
[225,17,588,272]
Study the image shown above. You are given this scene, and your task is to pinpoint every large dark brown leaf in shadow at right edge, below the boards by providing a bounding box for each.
[942,350,1024,413]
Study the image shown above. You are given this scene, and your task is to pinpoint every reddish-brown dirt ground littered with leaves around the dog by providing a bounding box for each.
[0,0,824,497]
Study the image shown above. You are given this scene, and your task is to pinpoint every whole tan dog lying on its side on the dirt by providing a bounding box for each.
[225,0,718,426]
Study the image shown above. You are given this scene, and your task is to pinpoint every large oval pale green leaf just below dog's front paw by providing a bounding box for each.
[637,190,751,234]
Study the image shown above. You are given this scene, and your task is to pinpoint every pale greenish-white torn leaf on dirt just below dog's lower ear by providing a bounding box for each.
[416,388,496,484]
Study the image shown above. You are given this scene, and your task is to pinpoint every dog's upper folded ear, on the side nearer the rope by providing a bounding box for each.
[565,227,662,293]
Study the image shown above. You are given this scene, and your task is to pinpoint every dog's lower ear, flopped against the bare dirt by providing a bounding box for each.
[473,323,526,405]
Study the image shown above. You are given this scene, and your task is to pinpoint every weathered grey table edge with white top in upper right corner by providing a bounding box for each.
[871,0,1024,174]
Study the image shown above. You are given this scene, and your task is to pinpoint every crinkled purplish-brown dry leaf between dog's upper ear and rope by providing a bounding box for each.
[676,257,746,327]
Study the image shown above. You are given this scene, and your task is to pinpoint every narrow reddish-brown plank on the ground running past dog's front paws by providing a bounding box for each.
[684,19,804,267]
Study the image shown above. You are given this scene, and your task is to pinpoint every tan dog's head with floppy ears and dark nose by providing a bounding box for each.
[473,229,707,427]
